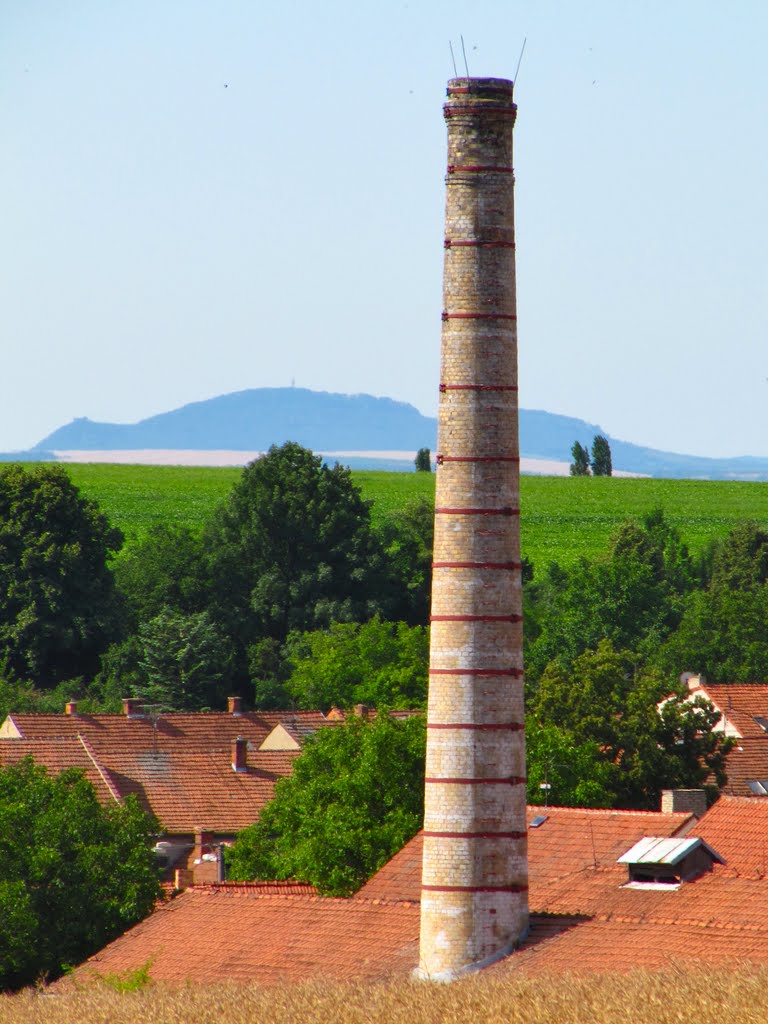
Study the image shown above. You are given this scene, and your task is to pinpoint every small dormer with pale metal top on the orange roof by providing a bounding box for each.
[616,836,725,890]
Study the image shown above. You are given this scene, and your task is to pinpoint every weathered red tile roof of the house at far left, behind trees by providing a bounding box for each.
[0,712,332,835]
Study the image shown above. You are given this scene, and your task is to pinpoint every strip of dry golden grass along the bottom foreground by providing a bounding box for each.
[0,966,768,1024]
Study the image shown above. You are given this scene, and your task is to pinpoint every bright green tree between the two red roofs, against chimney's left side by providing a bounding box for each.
[226,715,425,896]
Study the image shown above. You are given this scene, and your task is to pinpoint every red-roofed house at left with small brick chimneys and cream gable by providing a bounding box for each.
[0,697,335,884]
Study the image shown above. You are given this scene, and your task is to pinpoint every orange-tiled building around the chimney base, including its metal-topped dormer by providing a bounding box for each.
[63,796,768,983]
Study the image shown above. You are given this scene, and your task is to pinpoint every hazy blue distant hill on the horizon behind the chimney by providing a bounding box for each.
[9,388,768,480]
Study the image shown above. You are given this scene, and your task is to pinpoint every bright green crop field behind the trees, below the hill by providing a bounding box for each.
[67,465,768,565]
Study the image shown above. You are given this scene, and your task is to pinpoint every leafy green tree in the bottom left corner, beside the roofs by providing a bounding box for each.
[0,758,160,989]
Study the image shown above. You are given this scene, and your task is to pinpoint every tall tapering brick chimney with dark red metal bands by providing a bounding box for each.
[419,78,528,979]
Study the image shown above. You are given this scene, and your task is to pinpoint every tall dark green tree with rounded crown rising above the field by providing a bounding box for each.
[204,441,385,651]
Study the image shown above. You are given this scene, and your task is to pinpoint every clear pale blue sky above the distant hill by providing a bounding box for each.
[0,0,768,456]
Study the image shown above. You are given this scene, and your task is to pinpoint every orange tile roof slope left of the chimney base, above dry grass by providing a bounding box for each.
[70,886,419,983]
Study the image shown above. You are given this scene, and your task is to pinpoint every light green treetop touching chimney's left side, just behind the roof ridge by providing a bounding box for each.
[286,617,429,710]
